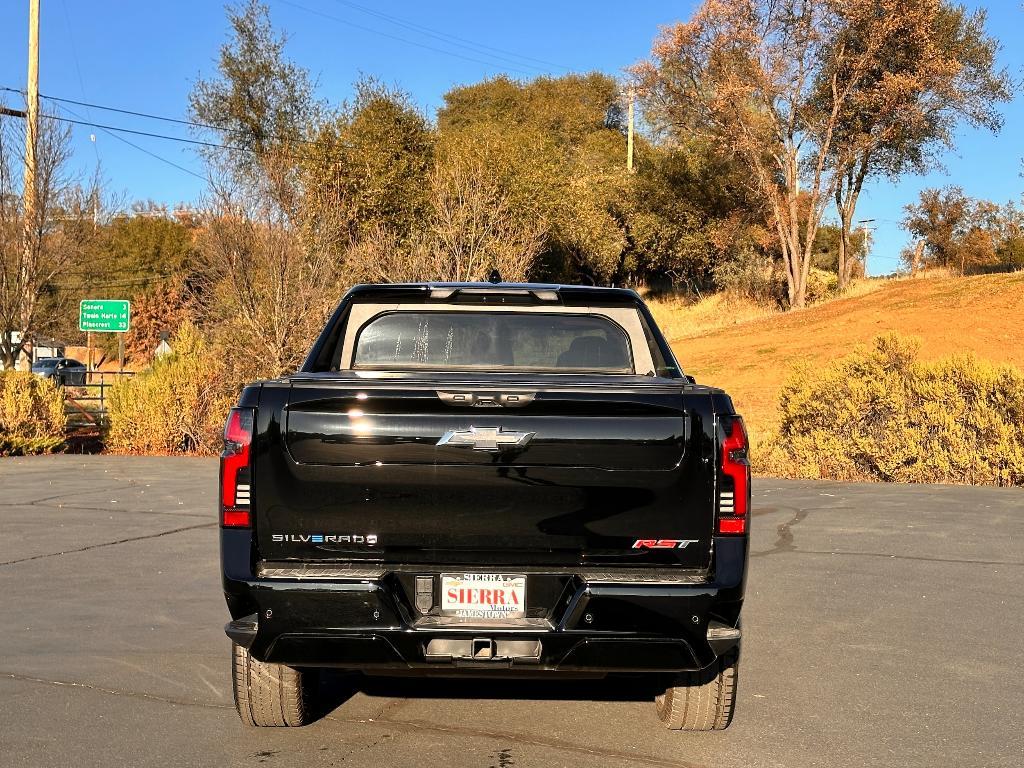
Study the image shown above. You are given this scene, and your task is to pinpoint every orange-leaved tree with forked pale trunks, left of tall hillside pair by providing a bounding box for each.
[635,0,1011,307]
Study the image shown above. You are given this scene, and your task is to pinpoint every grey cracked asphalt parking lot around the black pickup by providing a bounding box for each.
[0,456,1024,768]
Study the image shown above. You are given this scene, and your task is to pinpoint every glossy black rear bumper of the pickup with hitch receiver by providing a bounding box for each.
[221,529,748,674]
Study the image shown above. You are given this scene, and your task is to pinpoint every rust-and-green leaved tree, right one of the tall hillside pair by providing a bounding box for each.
[818,0,1012,288]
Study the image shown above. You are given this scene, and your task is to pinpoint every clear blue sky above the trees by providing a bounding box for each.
[0,0,1024,274]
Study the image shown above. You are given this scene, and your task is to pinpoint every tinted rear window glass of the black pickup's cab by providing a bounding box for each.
[352,311,633,374]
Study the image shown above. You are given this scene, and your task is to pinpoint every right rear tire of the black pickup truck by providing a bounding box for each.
[654,652,739,731]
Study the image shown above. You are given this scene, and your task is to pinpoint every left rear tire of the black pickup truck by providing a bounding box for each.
[231,643,316,727]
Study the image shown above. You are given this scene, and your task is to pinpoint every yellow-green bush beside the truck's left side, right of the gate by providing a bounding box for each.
[106,325,238,456]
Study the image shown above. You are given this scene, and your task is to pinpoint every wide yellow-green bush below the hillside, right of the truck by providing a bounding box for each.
[755,335,1024,485]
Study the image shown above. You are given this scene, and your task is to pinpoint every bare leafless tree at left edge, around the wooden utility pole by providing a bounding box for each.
[0,110,100,368]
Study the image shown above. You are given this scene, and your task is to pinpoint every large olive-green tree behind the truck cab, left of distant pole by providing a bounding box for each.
[437,73,629,283]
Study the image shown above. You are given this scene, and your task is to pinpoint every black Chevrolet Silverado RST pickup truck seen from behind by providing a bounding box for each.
[220,284,751,730]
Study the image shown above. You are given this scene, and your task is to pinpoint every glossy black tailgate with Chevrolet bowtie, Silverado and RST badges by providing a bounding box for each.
[254,377,715,567]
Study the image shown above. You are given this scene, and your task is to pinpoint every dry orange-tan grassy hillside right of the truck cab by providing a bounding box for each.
[653,272,1024,433]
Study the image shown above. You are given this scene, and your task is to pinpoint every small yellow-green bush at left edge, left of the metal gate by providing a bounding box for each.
[0,371,65,456]
